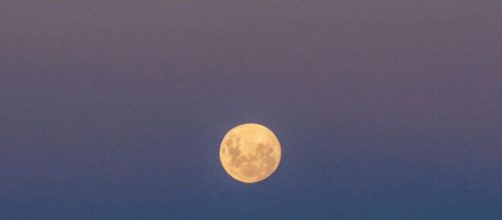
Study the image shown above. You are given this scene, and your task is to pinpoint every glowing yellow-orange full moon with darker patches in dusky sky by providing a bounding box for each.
[220,123,281,183]
